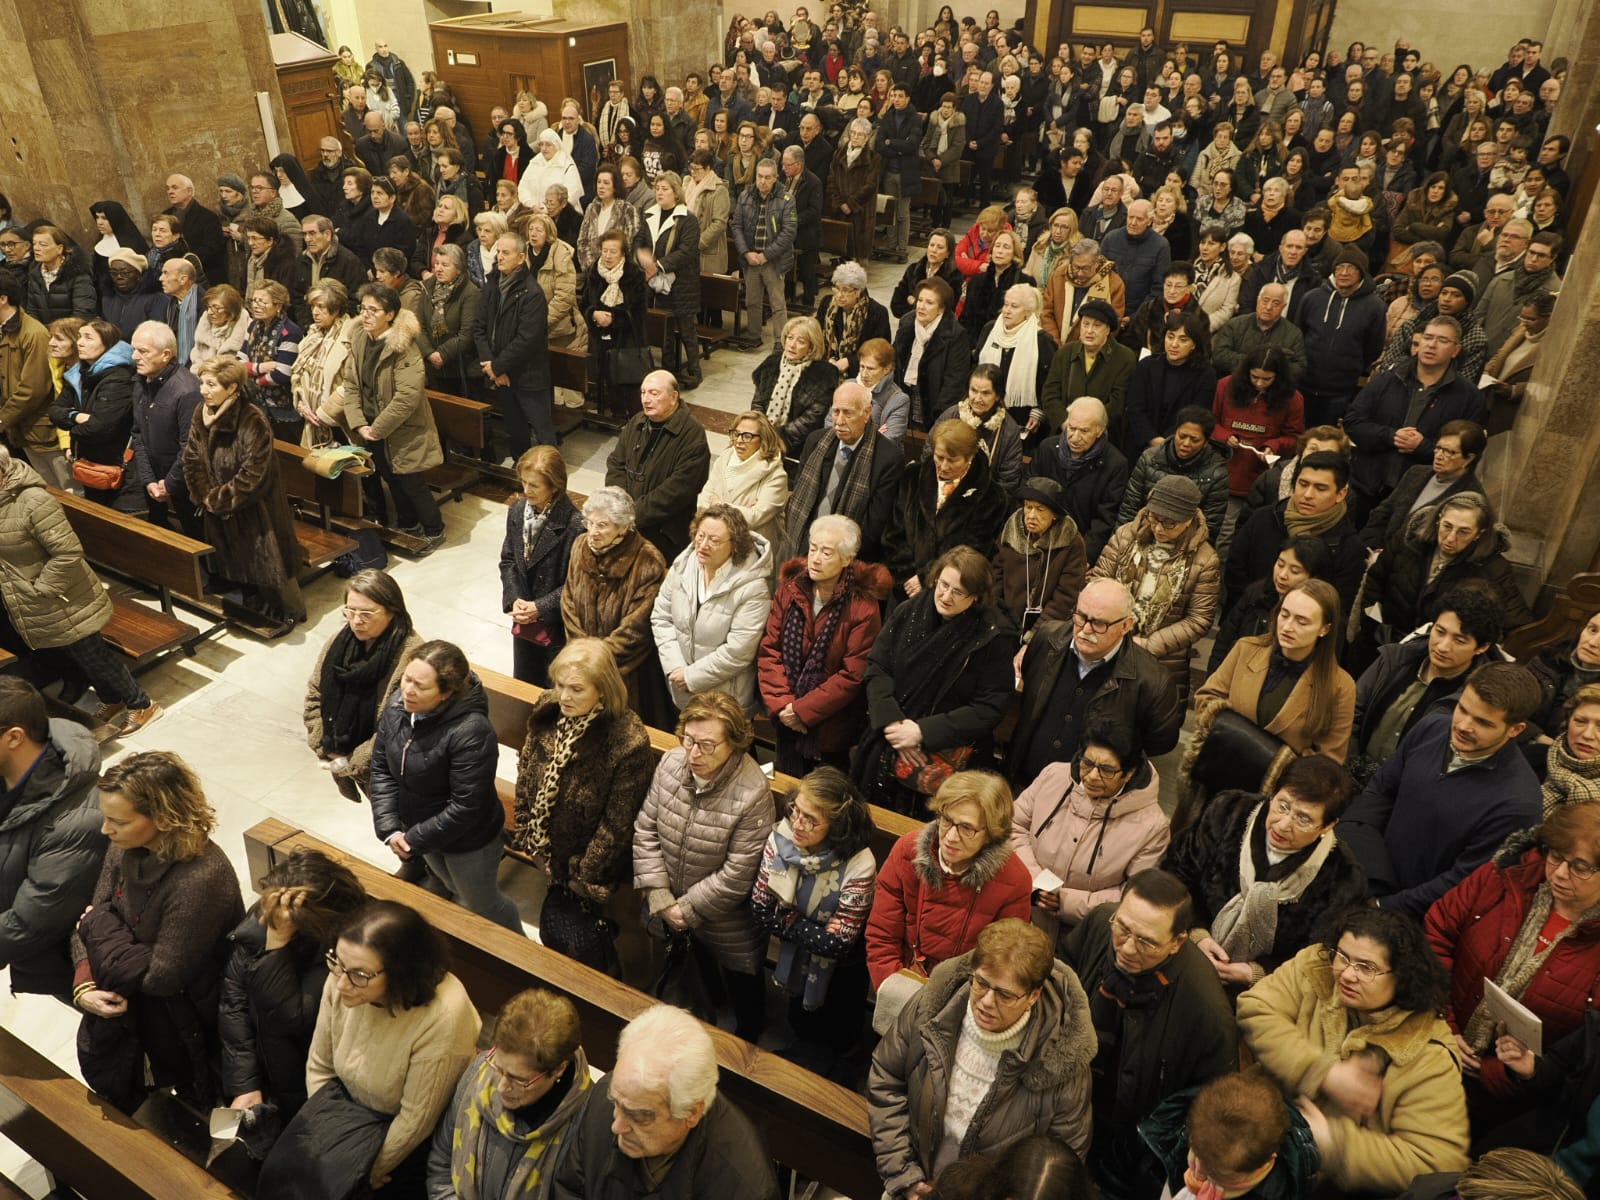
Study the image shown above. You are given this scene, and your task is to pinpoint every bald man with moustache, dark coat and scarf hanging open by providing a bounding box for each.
[781,379,906,562]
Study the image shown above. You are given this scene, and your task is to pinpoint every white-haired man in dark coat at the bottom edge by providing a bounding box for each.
[550,1005,778,1200]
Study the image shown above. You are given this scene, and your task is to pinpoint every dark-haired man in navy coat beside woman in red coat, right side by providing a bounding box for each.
[1342,662,1541,918]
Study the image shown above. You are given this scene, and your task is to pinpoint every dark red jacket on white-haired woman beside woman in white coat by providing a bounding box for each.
[755,558,894,754]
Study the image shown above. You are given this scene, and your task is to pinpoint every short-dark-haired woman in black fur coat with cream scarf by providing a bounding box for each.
[1162,754,1366,987]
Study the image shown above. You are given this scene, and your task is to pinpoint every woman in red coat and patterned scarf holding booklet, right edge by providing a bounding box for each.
[1427,805,1600,1128]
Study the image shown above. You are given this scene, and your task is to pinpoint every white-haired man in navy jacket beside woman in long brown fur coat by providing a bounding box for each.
[131,324,205,539]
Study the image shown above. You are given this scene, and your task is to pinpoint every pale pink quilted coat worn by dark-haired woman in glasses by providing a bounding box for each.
[1011,762,1171,941]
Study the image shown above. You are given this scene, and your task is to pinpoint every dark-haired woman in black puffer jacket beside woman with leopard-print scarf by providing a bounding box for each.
[370,642,522,934]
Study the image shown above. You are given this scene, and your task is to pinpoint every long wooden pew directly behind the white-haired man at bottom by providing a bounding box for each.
[240,819,883,1200]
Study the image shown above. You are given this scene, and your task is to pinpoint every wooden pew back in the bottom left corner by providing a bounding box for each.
[0,1029,243,1200]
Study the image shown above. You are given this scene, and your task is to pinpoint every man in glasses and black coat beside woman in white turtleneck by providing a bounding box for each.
[1061,870,1238,1200]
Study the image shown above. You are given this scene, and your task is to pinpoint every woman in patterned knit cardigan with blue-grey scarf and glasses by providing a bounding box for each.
[750,766,878,1075]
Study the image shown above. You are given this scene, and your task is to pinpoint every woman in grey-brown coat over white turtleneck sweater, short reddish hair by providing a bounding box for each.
[867,920,1098,1198]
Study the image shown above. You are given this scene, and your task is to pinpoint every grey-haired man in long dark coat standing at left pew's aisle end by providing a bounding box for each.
[472,234,558,462]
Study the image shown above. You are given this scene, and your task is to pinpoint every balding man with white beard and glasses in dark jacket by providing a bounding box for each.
[1006,579,1184,789]
